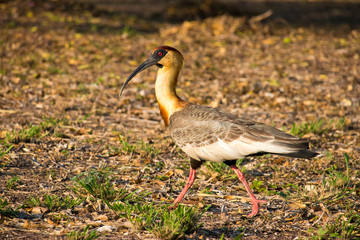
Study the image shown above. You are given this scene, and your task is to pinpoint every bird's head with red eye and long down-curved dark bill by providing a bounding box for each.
[120,46,184,96]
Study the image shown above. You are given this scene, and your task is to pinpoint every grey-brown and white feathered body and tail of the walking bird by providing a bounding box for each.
[169,104,316,162]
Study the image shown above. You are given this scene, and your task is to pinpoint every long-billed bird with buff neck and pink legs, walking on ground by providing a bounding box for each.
[119,46,318,217]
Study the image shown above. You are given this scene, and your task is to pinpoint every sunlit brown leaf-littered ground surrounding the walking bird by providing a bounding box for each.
[0,1,360,239]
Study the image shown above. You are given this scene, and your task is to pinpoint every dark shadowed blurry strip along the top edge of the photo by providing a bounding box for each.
[1,0,360,31]
